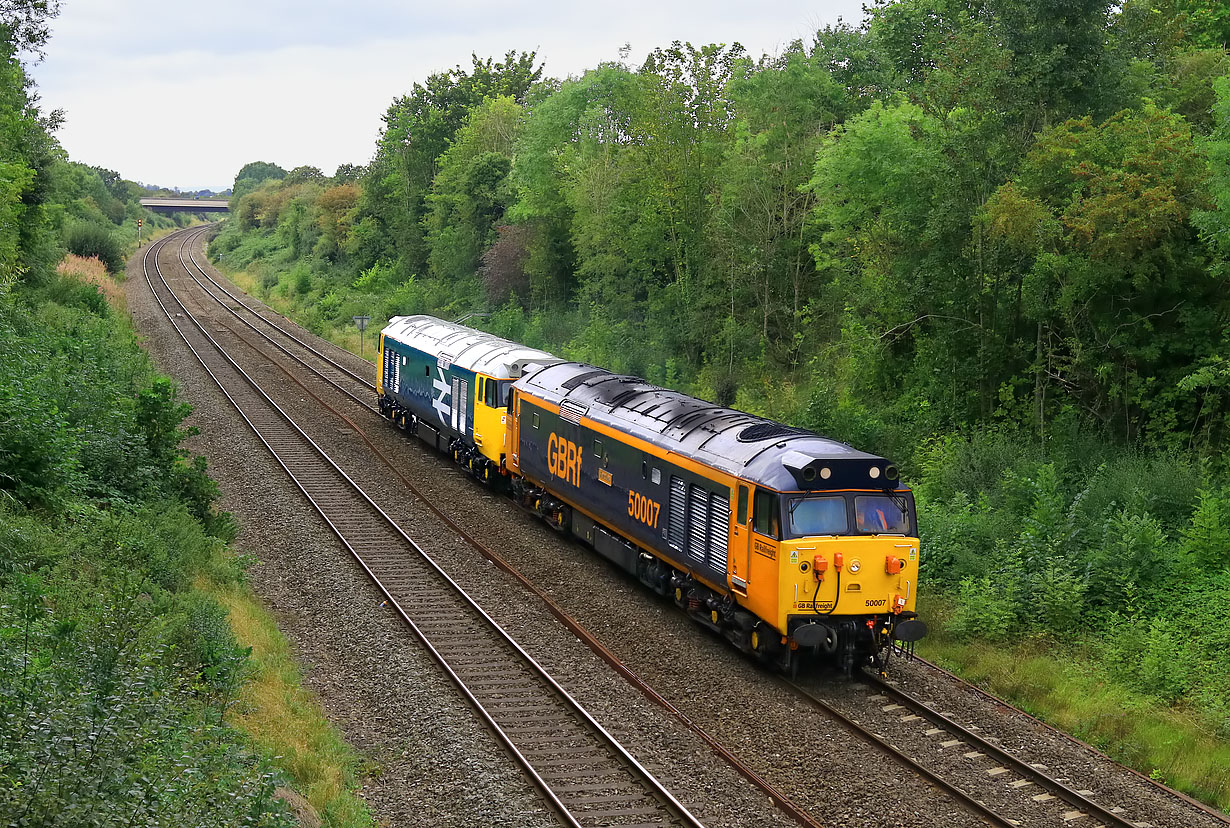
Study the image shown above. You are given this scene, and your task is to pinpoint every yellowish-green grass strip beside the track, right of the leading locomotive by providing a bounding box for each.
[919,595,1230,812]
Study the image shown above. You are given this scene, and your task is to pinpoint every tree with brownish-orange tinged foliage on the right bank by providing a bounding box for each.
[988,105,1224,438]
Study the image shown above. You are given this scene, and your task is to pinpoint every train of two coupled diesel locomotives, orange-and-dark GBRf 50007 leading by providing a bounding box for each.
[376,316,926,672]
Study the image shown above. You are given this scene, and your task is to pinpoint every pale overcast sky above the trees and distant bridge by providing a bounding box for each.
[31,0,862,189]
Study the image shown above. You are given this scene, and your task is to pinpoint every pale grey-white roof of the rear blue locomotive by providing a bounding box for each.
[381,314,560,379]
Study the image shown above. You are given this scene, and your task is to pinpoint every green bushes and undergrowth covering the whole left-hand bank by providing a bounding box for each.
[0,2,371,828]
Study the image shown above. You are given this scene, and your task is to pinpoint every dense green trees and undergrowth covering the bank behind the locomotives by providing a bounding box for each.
[212,0,1230,806]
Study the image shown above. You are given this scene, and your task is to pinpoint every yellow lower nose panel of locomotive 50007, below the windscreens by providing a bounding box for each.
[776,535,919,634]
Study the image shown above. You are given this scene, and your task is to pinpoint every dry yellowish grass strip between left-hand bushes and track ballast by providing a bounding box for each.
[197,568,374,828]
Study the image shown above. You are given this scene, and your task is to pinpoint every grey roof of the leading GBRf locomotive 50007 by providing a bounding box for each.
[517,362,903,491]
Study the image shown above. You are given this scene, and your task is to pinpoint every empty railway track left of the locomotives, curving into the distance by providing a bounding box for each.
[143,227,701,828]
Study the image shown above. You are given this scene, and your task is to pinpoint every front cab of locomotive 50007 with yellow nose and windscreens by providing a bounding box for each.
[731,452,926,671]
